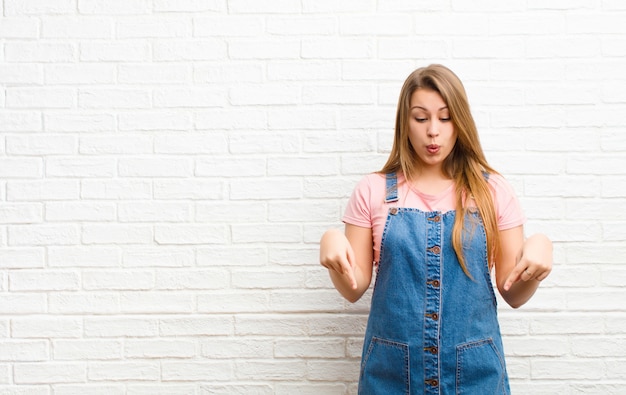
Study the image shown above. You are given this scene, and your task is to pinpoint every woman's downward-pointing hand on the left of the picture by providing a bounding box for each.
[320,229,357,290]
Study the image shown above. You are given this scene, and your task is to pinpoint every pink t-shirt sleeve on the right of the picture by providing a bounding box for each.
[489,174,526,230]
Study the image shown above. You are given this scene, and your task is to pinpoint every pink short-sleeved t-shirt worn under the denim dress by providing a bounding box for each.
[342,173,526,262]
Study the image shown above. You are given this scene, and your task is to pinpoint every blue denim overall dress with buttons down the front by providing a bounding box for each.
[359,174,510,395]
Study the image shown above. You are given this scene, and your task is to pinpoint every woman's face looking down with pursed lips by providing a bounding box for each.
[409,88,457,169]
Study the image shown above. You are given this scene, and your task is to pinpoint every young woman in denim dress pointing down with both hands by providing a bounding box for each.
[320,65,552,394]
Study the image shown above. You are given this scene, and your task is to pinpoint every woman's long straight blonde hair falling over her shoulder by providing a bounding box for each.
[380,64,499,277]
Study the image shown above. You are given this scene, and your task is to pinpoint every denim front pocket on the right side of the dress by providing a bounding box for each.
[456,339,508,395]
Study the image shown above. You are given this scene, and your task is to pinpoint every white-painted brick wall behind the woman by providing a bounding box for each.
[0,0,626,395]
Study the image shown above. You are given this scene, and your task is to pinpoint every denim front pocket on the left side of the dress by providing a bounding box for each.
[359,337,410,395]
